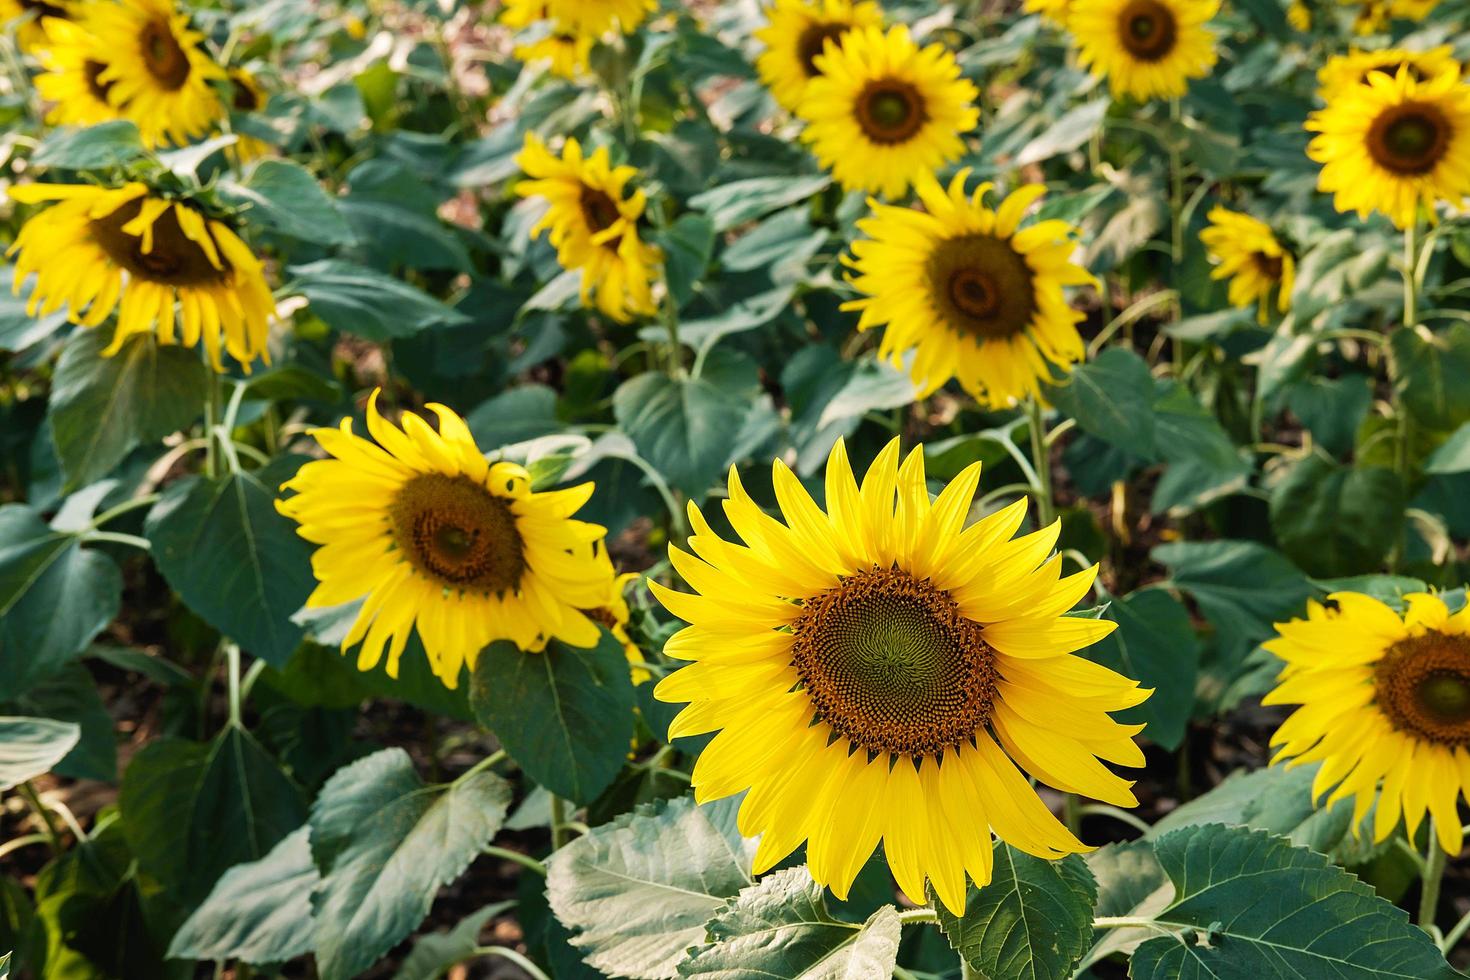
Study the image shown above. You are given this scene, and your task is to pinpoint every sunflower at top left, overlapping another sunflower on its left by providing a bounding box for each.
[87,0,225,145]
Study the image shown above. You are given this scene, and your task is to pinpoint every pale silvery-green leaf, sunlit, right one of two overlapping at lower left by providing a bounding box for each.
[312,743,514,980]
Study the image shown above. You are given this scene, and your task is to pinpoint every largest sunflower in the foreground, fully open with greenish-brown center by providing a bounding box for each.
[651,439,1150,912]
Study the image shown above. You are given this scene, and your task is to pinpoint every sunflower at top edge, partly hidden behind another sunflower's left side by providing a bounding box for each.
[756,0,883,112]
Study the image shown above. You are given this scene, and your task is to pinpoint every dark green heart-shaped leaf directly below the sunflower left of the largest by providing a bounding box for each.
[469,630,635,804]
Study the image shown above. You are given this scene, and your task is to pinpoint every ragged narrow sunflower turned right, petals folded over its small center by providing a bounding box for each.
[516,132,663,322]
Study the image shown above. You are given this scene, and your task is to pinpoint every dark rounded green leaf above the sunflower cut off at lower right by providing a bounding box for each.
[1272,454,1407,577]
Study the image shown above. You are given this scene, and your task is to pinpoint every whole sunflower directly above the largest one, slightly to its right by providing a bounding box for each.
[844,170,1094,408]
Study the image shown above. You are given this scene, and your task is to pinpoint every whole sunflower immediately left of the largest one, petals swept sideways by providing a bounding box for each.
[276,392,613,688]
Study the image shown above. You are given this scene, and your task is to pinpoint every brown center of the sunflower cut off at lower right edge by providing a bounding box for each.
[1373,632,1470,745]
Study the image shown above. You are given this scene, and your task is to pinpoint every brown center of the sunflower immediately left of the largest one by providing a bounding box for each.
[388,473,526,594]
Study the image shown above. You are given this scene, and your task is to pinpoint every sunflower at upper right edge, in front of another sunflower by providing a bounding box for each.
[1307,66,1470,228]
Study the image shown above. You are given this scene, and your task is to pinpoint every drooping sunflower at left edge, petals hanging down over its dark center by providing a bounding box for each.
[9,184,275,370]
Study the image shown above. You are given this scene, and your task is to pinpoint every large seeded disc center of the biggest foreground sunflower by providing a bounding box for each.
[791,566,995,755]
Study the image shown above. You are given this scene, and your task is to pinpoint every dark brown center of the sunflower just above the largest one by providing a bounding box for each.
[929,235,1036,339]
